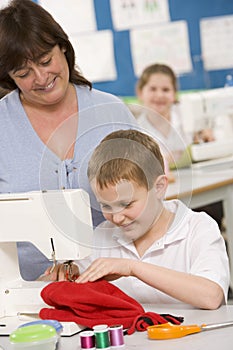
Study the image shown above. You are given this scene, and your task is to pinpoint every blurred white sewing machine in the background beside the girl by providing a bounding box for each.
[179,87,233,166]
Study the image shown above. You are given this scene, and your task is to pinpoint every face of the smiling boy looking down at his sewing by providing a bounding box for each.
[92,180,162,240]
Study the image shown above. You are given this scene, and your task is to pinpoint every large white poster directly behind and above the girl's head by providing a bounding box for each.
[130,21,192,76]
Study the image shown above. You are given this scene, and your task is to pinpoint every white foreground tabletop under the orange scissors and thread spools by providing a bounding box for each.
[0,304,233,350]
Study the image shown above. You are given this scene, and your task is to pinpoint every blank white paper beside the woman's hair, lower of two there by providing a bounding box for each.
[70,30,117,82]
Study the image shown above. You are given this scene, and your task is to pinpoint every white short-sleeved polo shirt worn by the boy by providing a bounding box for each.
[79,200,230,303]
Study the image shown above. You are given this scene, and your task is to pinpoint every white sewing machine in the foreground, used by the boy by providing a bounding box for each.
[0,189,93,335]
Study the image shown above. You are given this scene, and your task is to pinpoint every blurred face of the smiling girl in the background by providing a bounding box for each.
[138,73,176,116]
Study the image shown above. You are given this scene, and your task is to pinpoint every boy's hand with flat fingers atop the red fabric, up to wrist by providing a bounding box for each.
[75,258,132,283]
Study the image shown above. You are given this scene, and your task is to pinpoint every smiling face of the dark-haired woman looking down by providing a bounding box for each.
[9,45,69,105]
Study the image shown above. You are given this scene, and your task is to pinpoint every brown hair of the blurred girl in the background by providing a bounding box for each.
[136,63,178,92]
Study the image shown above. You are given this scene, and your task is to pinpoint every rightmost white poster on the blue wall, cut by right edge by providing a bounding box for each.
[200,15,233,70]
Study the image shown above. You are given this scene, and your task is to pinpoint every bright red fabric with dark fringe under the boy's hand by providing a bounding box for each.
[39,280,182,334]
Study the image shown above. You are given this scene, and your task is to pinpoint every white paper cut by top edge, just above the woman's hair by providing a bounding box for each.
[38,0,97,35]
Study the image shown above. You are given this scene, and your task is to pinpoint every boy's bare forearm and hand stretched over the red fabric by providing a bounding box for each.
[76,258,224,309]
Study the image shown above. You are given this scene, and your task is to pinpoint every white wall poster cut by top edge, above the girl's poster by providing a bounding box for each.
[110,0,170,30]
